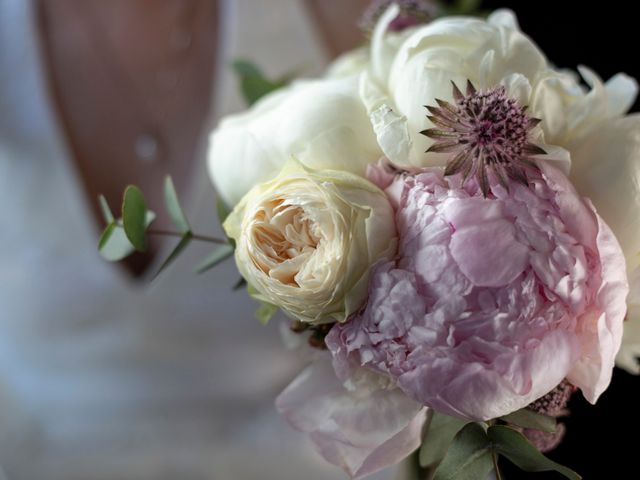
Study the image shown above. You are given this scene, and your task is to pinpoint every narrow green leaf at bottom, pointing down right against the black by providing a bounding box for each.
[487,425,582,480]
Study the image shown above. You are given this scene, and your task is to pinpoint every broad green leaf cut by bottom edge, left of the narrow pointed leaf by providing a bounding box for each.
[433,423,493,480]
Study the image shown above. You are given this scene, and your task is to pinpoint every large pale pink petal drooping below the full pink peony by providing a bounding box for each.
[276,358,427,478]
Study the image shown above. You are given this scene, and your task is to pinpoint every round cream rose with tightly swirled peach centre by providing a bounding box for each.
[224,161,396,323]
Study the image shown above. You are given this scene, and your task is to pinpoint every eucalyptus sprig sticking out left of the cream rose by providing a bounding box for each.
[98,177,235,276]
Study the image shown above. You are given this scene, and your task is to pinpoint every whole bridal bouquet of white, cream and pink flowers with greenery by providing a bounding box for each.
[101,2,640,480]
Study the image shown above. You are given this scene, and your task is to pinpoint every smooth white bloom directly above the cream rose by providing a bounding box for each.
[208,73,382,205]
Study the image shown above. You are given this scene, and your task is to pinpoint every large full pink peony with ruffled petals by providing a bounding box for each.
[327,162,628,420]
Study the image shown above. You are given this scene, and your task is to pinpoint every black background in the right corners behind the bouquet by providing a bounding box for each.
[483,0,640,480]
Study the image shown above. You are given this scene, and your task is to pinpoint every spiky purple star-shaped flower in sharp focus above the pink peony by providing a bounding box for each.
[420,81,546,197]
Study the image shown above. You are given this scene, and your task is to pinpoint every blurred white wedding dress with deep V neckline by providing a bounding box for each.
[0,0,387,480]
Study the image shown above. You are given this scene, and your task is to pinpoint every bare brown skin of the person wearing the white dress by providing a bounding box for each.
[37,0,368,276]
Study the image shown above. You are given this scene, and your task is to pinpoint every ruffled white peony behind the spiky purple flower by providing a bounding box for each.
[361,7,637,172]
